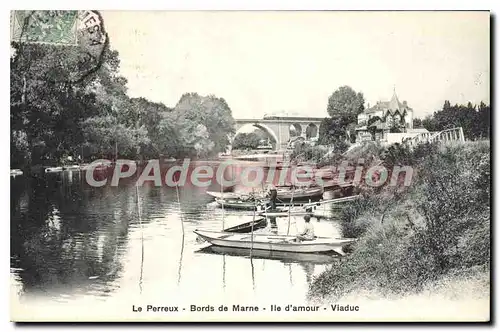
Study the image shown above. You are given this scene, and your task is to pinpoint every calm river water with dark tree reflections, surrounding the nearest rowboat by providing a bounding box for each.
[11,165,340,320]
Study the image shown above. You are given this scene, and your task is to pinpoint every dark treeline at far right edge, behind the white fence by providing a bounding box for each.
[413,100,491,140]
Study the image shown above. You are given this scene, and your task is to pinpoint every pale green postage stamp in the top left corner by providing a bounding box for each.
[11,10,78,45]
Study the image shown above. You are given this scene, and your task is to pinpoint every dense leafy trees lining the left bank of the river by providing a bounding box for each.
[10,43,234,168]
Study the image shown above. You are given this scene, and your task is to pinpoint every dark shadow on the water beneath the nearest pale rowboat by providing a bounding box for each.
[196,245,337,264]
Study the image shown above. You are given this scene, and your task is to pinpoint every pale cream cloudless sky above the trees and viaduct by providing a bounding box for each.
[101,11,490,118]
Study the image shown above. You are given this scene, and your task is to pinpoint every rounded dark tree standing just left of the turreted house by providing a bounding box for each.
[327,86,365,117]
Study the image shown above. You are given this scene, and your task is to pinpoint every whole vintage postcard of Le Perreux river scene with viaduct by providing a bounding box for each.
[10,10,491,322]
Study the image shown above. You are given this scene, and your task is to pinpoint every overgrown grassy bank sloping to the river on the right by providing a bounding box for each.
[309,141,490,300]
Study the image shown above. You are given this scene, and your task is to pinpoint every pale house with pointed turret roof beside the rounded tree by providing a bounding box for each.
[356,90,413,140]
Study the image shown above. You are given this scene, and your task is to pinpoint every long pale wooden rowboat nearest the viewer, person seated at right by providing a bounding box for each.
[194,230,356,255]
